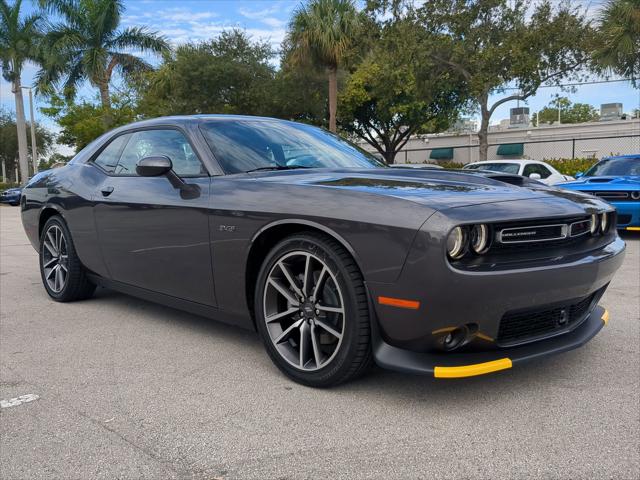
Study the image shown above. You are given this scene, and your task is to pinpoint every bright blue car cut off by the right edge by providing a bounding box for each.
[556,154,640,231]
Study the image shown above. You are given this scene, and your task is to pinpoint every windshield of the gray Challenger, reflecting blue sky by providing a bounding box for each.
[200,119,385,173]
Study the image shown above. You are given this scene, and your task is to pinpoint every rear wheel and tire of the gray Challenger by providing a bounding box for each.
[40,215,96,302]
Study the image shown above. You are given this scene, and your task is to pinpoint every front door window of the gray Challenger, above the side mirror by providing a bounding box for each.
[115,129,207,177]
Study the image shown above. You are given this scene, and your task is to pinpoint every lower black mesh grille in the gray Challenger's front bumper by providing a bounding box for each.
[497,292,598,346]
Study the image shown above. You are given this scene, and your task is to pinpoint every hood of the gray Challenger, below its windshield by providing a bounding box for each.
[248,168,604,210]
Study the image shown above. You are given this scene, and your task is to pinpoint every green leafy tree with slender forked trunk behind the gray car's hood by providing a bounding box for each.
[416,0,593,160]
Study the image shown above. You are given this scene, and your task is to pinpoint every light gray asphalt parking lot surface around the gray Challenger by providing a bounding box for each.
[0,207,640,480]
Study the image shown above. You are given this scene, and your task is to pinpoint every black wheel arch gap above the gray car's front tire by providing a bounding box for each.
[245,219,368,328]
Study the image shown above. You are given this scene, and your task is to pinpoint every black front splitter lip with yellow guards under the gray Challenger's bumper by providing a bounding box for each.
[374,306,609,378]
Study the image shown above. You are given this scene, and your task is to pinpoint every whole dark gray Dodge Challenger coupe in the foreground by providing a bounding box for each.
[21,115,625,387]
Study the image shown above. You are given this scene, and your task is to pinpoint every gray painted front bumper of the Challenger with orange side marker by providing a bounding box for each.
[368,234,625,350]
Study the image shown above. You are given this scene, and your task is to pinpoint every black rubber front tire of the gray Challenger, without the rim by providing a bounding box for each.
[254,234,369,387]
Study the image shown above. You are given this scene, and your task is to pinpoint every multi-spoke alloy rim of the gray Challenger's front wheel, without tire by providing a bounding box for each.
[262,251,345,371]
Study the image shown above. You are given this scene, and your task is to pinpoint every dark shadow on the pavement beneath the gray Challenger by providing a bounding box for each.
[87,289,590,408]
